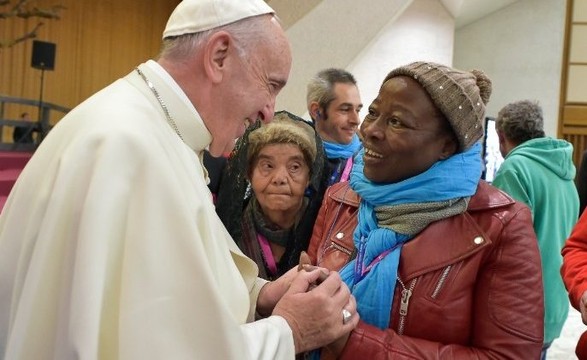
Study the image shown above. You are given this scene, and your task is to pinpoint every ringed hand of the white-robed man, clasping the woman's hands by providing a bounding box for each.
[273,268,359,353]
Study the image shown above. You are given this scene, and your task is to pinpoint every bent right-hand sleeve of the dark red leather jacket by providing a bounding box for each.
[341,205,544,360]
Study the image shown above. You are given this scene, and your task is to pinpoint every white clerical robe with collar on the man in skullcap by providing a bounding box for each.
[0,61,294,360]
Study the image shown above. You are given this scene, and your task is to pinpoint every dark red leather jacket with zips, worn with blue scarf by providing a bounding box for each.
[309,182,544,359]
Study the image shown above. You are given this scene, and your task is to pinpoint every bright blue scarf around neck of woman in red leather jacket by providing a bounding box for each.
[340,143,482,329]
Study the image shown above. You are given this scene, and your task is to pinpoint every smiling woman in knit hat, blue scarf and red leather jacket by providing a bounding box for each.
[309,62,543,359]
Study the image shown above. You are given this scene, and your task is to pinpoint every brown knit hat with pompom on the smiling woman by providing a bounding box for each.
[383,61,491,151]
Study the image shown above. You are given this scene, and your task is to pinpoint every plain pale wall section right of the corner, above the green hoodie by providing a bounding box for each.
[453,0,566,137]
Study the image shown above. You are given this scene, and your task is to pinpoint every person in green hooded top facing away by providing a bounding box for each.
[493,100,579,359]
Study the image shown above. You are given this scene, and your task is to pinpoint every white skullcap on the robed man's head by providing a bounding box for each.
[163,0,274,39]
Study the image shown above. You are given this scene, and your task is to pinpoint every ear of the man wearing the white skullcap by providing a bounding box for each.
[204,31,236,83]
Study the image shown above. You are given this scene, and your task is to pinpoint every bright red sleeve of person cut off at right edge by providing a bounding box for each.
[561,213,587,309]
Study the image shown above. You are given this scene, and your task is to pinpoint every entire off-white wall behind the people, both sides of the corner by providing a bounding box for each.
[276,0,566,136]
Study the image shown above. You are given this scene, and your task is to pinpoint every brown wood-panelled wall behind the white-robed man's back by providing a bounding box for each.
[0,0,179,129]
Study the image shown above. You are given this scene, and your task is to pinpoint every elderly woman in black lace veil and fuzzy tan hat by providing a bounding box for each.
[216,111,328,279]
